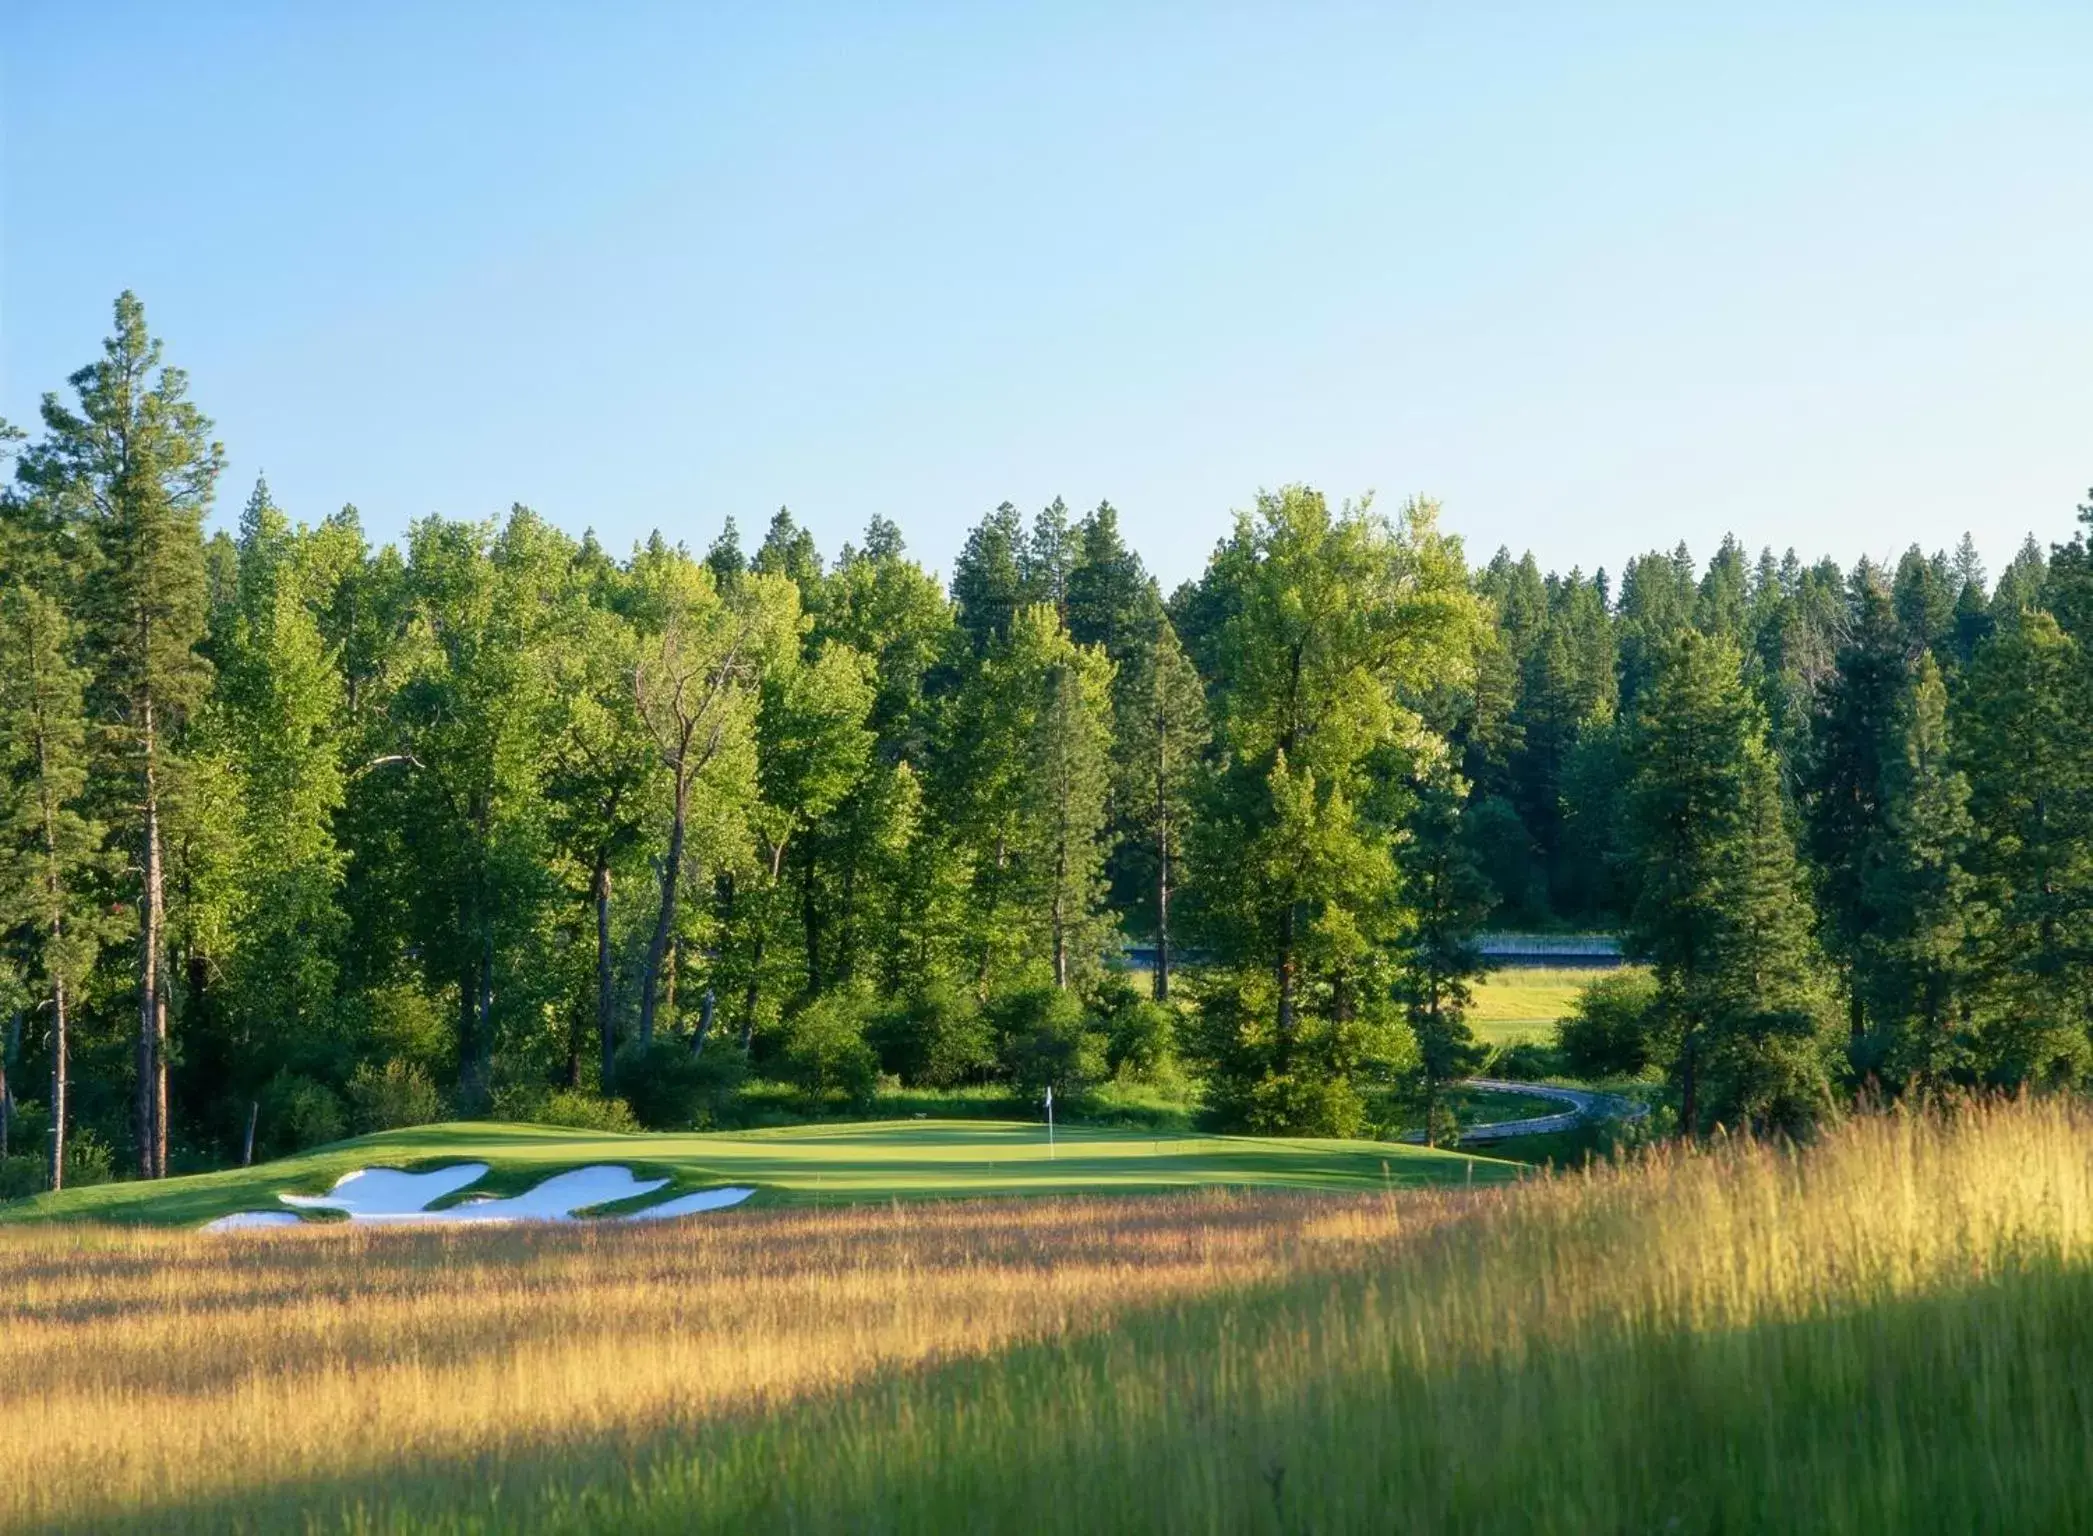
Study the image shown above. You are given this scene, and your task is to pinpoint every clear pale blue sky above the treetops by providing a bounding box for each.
[0,0,2093,582]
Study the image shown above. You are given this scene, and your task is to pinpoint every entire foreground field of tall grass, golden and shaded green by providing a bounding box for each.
[0,1101,2093,1532]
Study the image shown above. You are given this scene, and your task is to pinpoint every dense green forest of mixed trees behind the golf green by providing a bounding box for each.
[0,293,2093,1195]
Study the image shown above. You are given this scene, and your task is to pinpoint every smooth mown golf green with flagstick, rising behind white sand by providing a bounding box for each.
[0,1120,1517,1226]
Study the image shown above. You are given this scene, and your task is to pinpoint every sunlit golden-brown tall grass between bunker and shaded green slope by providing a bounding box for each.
[0,1195,1456,1526]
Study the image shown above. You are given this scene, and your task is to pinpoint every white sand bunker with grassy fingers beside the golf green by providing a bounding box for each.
[203,1164,756,1233]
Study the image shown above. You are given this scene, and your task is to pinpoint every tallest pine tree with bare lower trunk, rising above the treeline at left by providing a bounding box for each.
[21,293,224,1178]
